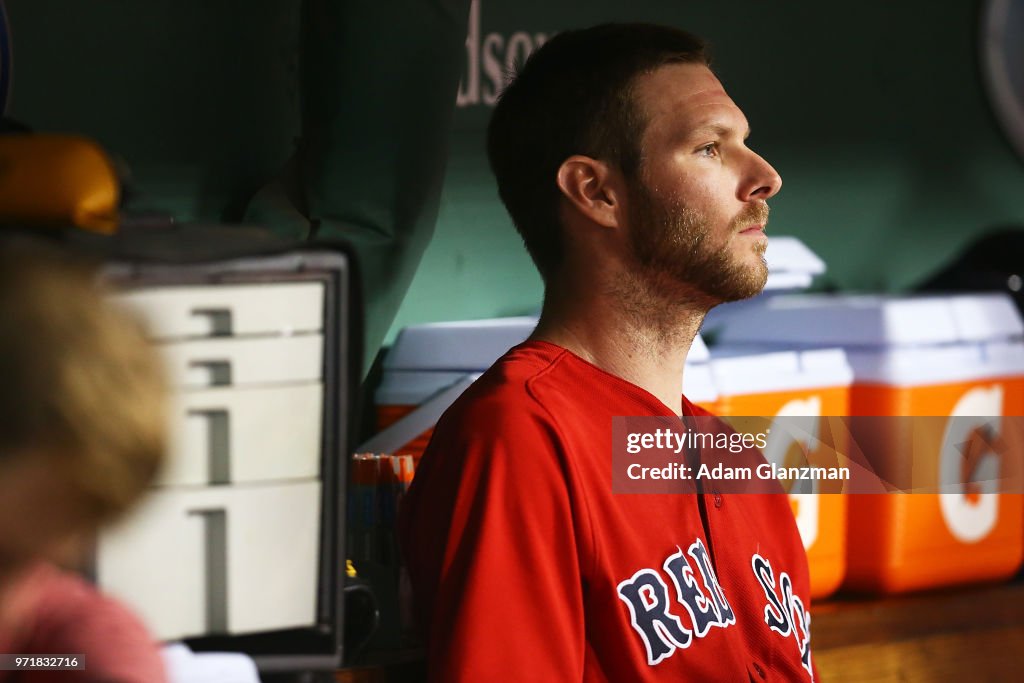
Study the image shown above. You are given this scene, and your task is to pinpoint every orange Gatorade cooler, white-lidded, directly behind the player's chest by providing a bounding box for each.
[710,346,853,598]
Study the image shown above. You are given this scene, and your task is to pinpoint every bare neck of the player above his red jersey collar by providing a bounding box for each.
[530,274,708,415]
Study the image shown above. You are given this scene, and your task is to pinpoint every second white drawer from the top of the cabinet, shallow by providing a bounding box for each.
[157,334,324,388]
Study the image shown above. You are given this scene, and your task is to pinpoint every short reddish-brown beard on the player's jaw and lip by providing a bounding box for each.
[630,182,768,308]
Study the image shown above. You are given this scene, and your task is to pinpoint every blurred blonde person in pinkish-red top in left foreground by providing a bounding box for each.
[0,239,167,683]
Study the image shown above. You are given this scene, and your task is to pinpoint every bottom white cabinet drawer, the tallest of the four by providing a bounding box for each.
[96,481,321,639]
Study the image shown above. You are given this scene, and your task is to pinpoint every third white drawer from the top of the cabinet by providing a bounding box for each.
[157,383,324,486]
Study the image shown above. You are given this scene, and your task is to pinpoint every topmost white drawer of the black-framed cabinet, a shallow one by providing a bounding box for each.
[115,283,324,340]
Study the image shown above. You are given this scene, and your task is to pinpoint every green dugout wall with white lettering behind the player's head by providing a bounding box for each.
[392,0,1024,334]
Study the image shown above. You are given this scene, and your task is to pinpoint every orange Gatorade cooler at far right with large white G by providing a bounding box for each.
[721,294,1024,593]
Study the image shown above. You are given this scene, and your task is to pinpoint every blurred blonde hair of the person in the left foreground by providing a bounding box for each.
[0,239,167,523]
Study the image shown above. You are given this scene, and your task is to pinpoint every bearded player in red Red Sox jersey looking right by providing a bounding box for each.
[400,25,814,683]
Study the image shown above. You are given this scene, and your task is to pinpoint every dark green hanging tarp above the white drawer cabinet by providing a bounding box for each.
[5,0,469,374]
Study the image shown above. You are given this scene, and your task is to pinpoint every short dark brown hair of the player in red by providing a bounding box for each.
[487,24,710,280]
